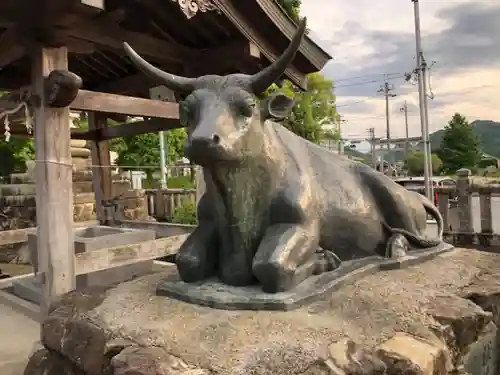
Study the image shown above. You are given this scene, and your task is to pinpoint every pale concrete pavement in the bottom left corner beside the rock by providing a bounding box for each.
[0,304,40,375]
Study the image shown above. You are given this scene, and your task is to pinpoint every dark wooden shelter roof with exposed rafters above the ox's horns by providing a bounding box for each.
[0,0,330,96]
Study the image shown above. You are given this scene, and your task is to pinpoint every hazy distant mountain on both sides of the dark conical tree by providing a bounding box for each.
[430,120,500,158]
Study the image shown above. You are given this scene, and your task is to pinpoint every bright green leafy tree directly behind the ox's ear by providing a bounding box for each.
[267,72,340,143]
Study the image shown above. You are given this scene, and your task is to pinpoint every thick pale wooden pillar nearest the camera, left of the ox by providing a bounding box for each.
[32,47,76,318]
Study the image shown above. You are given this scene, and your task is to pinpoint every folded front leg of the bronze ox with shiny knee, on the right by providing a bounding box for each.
[252,223,319,293]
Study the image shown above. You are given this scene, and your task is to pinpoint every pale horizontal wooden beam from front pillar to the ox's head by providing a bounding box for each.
[70,90,179,119]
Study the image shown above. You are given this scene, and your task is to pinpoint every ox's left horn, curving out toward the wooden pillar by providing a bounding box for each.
[123,42,196,95]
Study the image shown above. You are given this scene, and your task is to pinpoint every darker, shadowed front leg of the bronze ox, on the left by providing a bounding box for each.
[175,195,219,283]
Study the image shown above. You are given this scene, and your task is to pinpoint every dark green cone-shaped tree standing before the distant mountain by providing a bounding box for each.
[438,113,481,173]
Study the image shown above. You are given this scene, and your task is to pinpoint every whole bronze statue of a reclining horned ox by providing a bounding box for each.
[125,20,443,293]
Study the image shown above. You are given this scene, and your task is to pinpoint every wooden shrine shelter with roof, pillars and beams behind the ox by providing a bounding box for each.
[0,0,330,311]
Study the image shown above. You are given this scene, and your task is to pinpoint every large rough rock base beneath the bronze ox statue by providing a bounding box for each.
[25,249,500,375]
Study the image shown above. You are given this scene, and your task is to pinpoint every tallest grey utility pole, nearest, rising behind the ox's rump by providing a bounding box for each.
[411,0,434,202]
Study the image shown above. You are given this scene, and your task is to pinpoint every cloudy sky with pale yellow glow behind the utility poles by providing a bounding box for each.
[302,0,500,151]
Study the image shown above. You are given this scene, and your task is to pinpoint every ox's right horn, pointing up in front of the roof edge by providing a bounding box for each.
[250,17,306,95]
